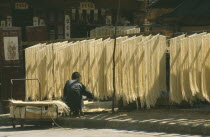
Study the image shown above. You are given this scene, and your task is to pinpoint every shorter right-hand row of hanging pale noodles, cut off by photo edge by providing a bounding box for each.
[170,33,210,103]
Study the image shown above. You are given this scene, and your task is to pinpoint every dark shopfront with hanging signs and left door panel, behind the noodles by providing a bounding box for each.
[0,0,148,112]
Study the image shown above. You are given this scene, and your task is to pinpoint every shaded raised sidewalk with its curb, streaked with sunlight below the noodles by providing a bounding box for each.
[0,109,210,136]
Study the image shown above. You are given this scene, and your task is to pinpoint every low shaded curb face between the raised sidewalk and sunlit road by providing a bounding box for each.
[57,118,210,135]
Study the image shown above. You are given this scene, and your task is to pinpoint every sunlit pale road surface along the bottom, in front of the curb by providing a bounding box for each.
[0,126,203,137]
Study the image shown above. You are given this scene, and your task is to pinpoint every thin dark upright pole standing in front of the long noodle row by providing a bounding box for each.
[112,0,120,114]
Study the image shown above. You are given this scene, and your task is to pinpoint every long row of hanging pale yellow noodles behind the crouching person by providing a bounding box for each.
[25,35,166,108]
